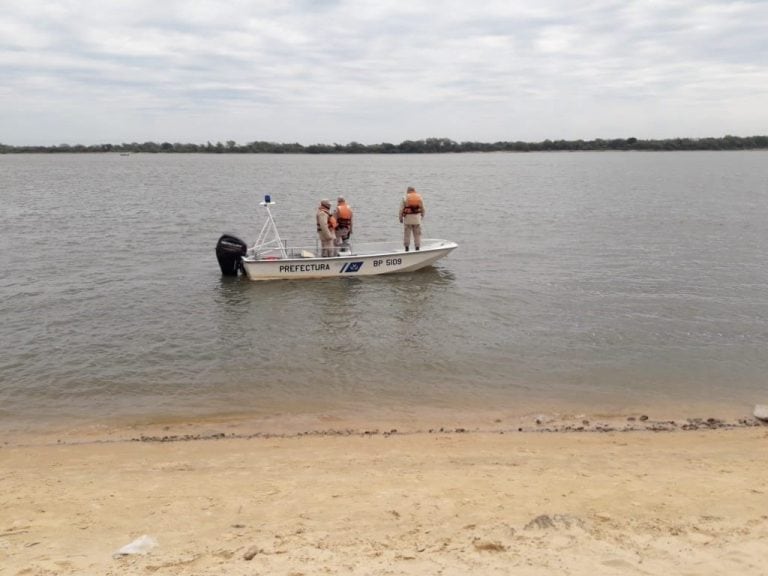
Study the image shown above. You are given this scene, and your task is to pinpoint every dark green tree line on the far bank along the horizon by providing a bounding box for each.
[0,136,768,154]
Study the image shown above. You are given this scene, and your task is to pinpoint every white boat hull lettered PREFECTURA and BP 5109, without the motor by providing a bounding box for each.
[242,240,457,280]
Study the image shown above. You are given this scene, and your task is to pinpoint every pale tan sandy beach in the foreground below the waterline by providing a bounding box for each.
[0,423,768,576]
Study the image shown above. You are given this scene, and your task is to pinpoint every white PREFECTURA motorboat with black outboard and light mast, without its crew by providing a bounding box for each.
[216,196,458,280]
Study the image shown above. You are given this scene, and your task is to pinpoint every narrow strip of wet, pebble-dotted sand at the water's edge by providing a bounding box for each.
[0,402,768,447]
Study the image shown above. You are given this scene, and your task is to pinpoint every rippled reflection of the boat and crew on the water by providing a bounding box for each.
[215,260,455,360]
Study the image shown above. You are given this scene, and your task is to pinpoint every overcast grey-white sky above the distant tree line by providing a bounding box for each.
[0,0,768,145]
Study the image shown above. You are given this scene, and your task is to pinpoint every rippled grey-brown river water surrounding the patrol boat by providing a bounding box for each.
[0,152,768,430]
